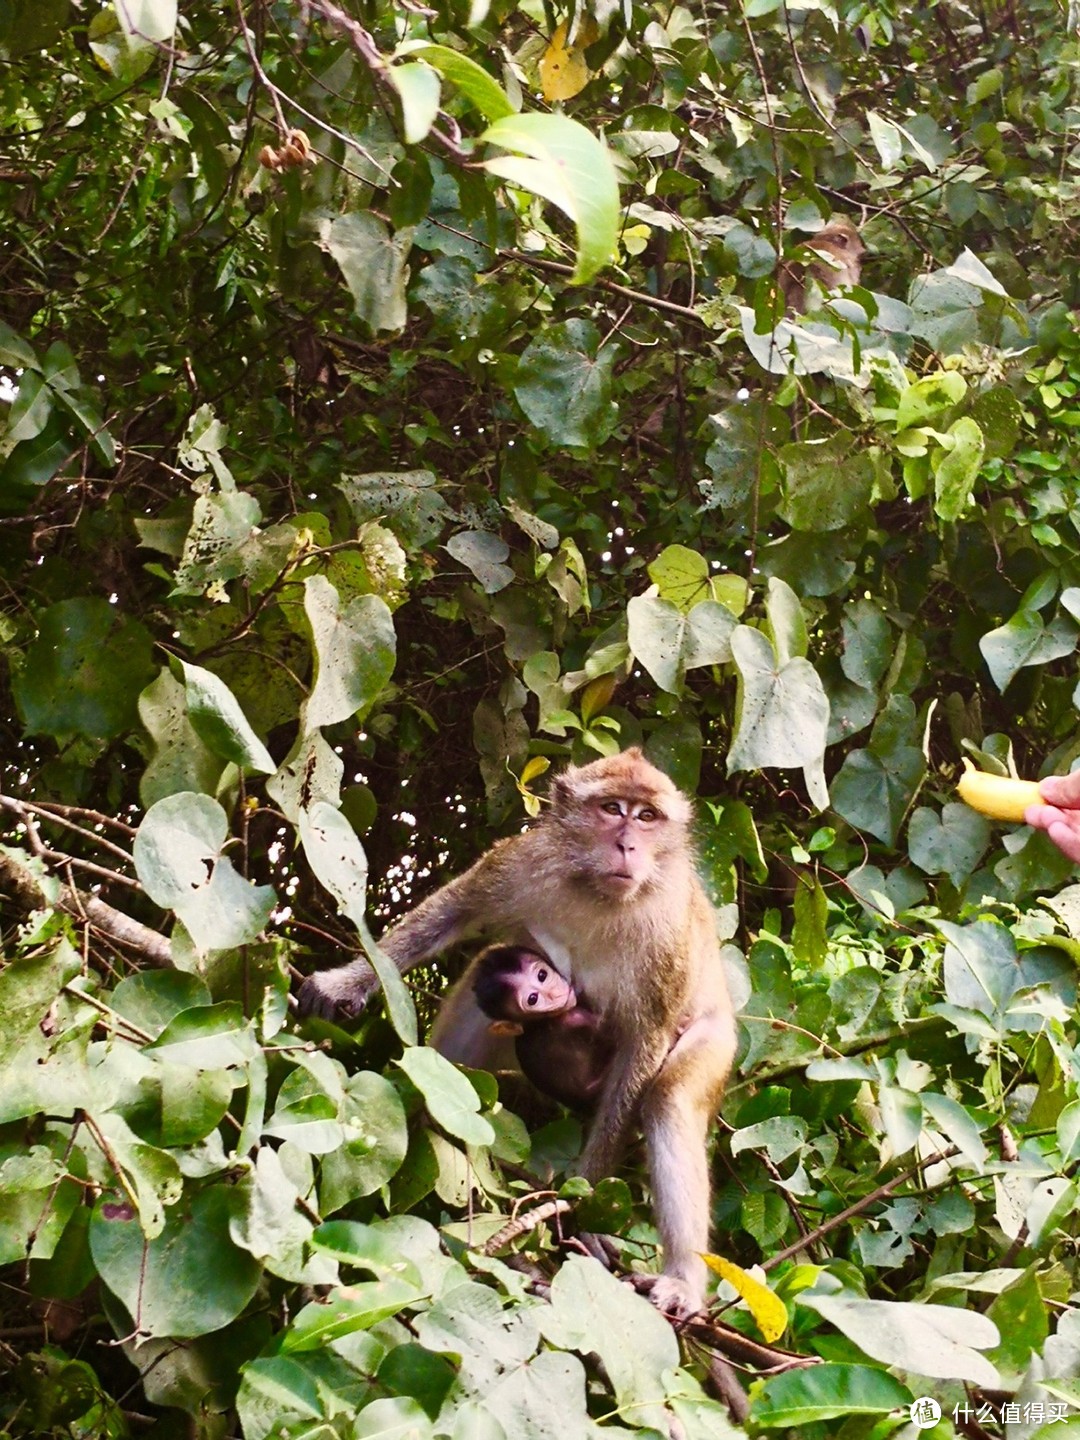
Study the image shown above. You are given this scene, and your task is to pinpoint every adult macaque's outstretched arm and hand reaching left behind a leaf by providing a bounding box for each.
[297,837,512,1020]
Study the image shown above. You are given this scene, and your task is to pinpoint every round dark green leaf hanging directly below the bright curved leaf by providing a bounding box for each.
[514,320,618,449]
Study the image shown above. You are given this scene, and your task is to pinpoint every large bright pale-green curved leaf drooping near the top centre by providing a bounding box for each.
[480,114,619,285]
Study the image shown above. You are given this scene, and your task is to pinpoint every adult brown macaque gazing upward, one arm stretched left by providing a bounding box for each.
[300,749,736,1315]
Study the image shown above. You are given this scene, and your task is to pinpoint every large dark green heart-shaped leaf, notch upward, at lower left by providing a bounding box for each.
[89,1185,262,1339]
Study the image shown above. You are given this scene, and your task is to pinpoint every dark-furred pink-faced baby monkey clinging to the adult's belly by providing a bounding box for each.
[471,945,615,1109]
